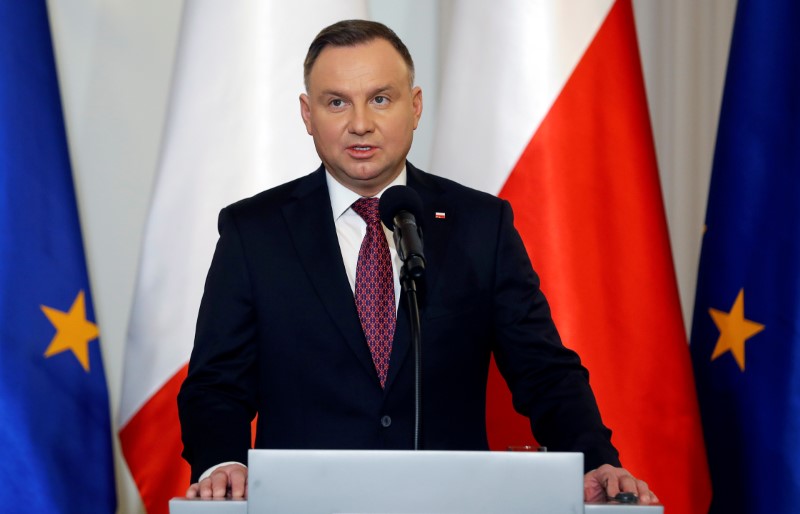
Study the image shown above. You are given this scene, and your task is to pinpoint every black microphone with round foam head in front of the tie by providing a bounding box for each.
[378,186,425,280]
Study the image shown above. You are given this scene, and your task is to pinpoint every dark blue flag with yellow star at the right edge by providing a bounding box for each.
[691,0,800,514]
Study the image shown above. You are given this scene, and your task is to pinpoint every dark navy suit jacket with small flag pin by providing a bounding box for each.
[178,164,619,481]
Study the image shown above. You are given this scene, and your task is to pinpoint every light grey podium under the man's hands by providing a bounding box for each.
[170,450,663,514]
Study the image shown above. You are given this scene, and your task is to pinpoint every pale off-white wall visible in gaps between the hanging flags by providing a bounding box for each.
[48,0,735,512]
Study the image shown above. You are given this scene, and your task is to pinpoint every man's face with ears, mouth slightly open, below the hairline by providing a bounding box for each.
[300,39,422,196]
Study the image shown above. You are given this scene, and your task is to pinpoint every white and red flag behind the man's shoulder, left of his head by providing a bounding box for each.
[119,0,366,514]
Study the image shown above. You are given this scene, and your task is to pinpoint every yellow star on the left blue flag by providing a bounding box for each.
[41,291,99,373]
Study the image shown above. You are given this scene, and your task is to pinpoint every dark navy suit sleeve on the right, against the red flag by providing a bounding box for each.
[494,198,620,471]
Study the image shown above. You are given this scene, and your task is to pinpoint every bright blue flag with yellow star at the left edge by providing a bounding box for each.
[0,0,116,513]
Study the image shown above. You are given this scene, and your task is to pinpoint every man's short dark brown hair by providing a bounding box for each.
[303,20,414,91]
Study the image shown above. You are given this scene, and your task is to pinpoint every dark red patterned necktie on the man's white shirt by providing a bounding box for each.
[352,198,396,387]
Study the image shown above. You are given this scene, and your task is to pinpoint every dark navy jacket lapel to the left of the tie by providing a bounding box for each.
[283,167,378,383]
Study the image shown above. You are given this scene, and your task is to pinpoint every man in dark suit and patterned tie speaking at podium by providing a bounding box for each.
[178,20,657,503]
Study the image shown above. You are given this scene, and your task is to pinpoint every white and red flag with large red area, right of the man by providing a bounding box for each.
[431,0,711,514]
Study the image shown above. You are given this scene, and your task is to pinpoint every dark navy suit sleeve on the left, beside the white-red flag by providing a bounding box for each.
[178,209,256,482]
